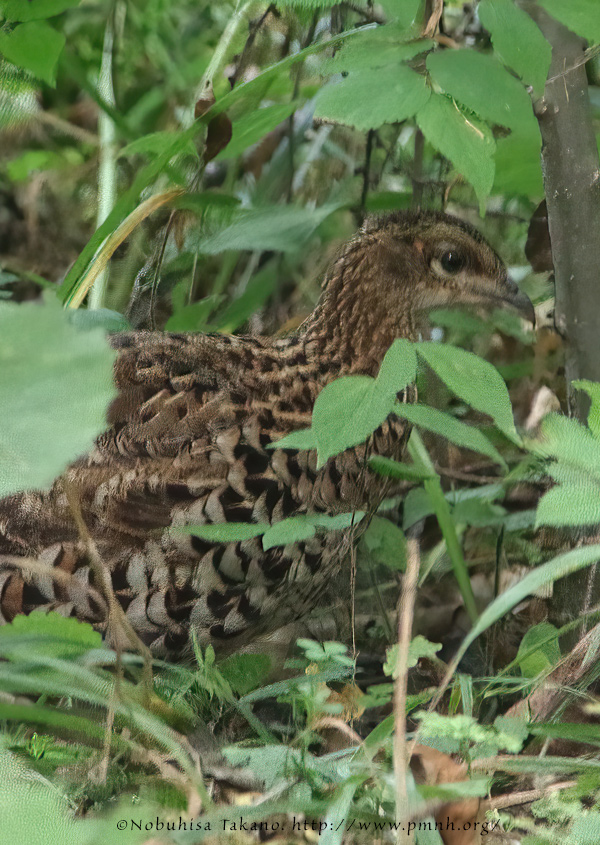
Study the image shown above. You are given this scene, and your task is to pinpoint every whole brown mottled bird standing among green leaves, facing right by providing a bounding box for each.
[0,212,532,655]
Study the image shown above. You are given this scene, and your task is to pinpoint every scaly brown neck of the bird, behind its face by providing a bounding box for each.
[301,244,417,375]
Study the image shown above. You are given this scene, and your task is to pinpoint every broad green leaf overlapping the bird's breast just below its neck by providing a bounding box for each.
[312,376,395,467]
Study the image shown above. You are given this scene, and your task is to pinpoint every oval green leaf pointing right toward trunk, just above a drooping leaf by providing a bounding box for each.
[427,49,535,130]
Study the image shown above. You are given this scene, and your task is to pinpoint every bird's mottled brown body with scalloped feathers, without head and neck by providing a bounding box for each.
[0,332,401,654]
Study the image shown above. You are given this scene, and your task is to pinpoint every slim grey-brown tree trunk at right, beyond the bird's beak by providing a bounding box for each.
[520,0,600,642]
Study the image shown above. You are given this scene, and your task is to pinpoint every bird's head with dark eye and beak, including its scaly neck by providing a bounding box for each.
[309,211,535,371]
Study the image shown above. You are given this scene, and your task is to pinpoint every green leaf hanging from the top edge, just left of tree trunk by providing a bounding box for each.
[477,0,552,96]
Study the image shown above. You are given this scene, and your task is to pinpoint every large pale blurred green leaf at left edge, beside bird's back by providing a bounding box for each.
[0,303,115,497]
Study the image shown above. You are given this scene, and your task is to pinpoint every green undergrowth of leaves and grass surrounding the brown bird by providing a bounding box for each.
[0,0,600,845]
